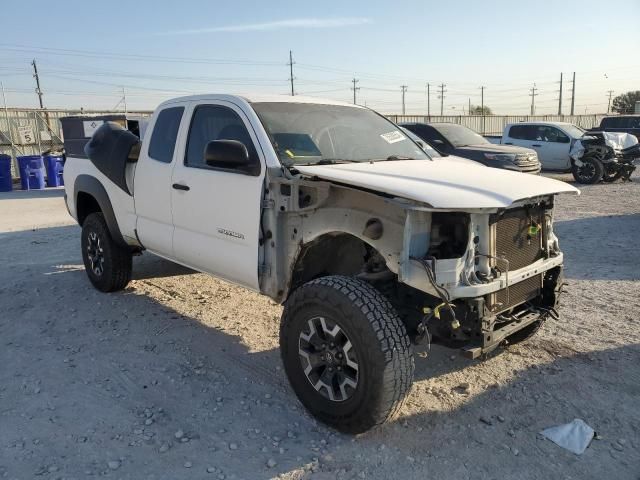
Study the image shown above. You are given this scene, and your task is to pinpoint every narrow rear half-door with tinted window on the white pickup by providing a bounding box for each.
[133,105,186,258]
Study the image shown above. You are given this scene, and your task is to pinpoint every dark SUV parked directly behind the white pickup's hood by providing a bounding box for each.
[401,123,540,173]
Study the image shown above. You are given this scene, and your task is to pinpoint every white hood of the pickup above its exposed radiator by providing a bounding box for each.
[295,157,580,209]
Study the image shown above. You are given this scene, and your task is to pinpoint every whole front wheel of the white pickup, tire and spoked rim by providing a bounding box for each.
[280,276,414,433]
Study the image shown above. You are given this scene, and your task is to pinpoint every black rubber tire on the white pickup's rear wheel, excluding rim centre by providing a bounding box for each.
[81,213,132,292]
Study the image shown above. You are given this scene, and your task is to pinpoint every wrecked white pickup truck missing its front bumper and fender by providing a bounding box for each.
[64,95,577,432]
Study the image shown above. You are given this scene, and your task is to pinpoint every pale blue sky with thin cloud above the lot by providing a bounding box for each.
[0,0,640,114]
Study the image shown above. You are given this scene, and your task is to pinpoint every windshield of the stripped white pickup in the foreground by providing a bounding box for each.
[252,102,429,166]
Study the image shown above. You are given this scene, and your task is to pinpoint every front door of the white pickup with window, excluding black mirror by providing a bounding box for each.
[171,101,265,290]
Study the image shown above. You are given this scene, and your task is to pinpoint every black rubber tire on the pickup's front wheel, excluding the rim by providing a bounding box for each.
[280,276,414,433]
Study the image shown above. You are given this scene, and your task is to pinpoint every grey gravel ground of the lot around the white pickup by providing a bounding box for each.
[0,176,640,480]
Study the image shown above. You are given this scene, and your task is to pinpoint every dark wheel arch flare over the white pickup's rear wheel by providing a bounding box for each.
[74,175,129,248]
